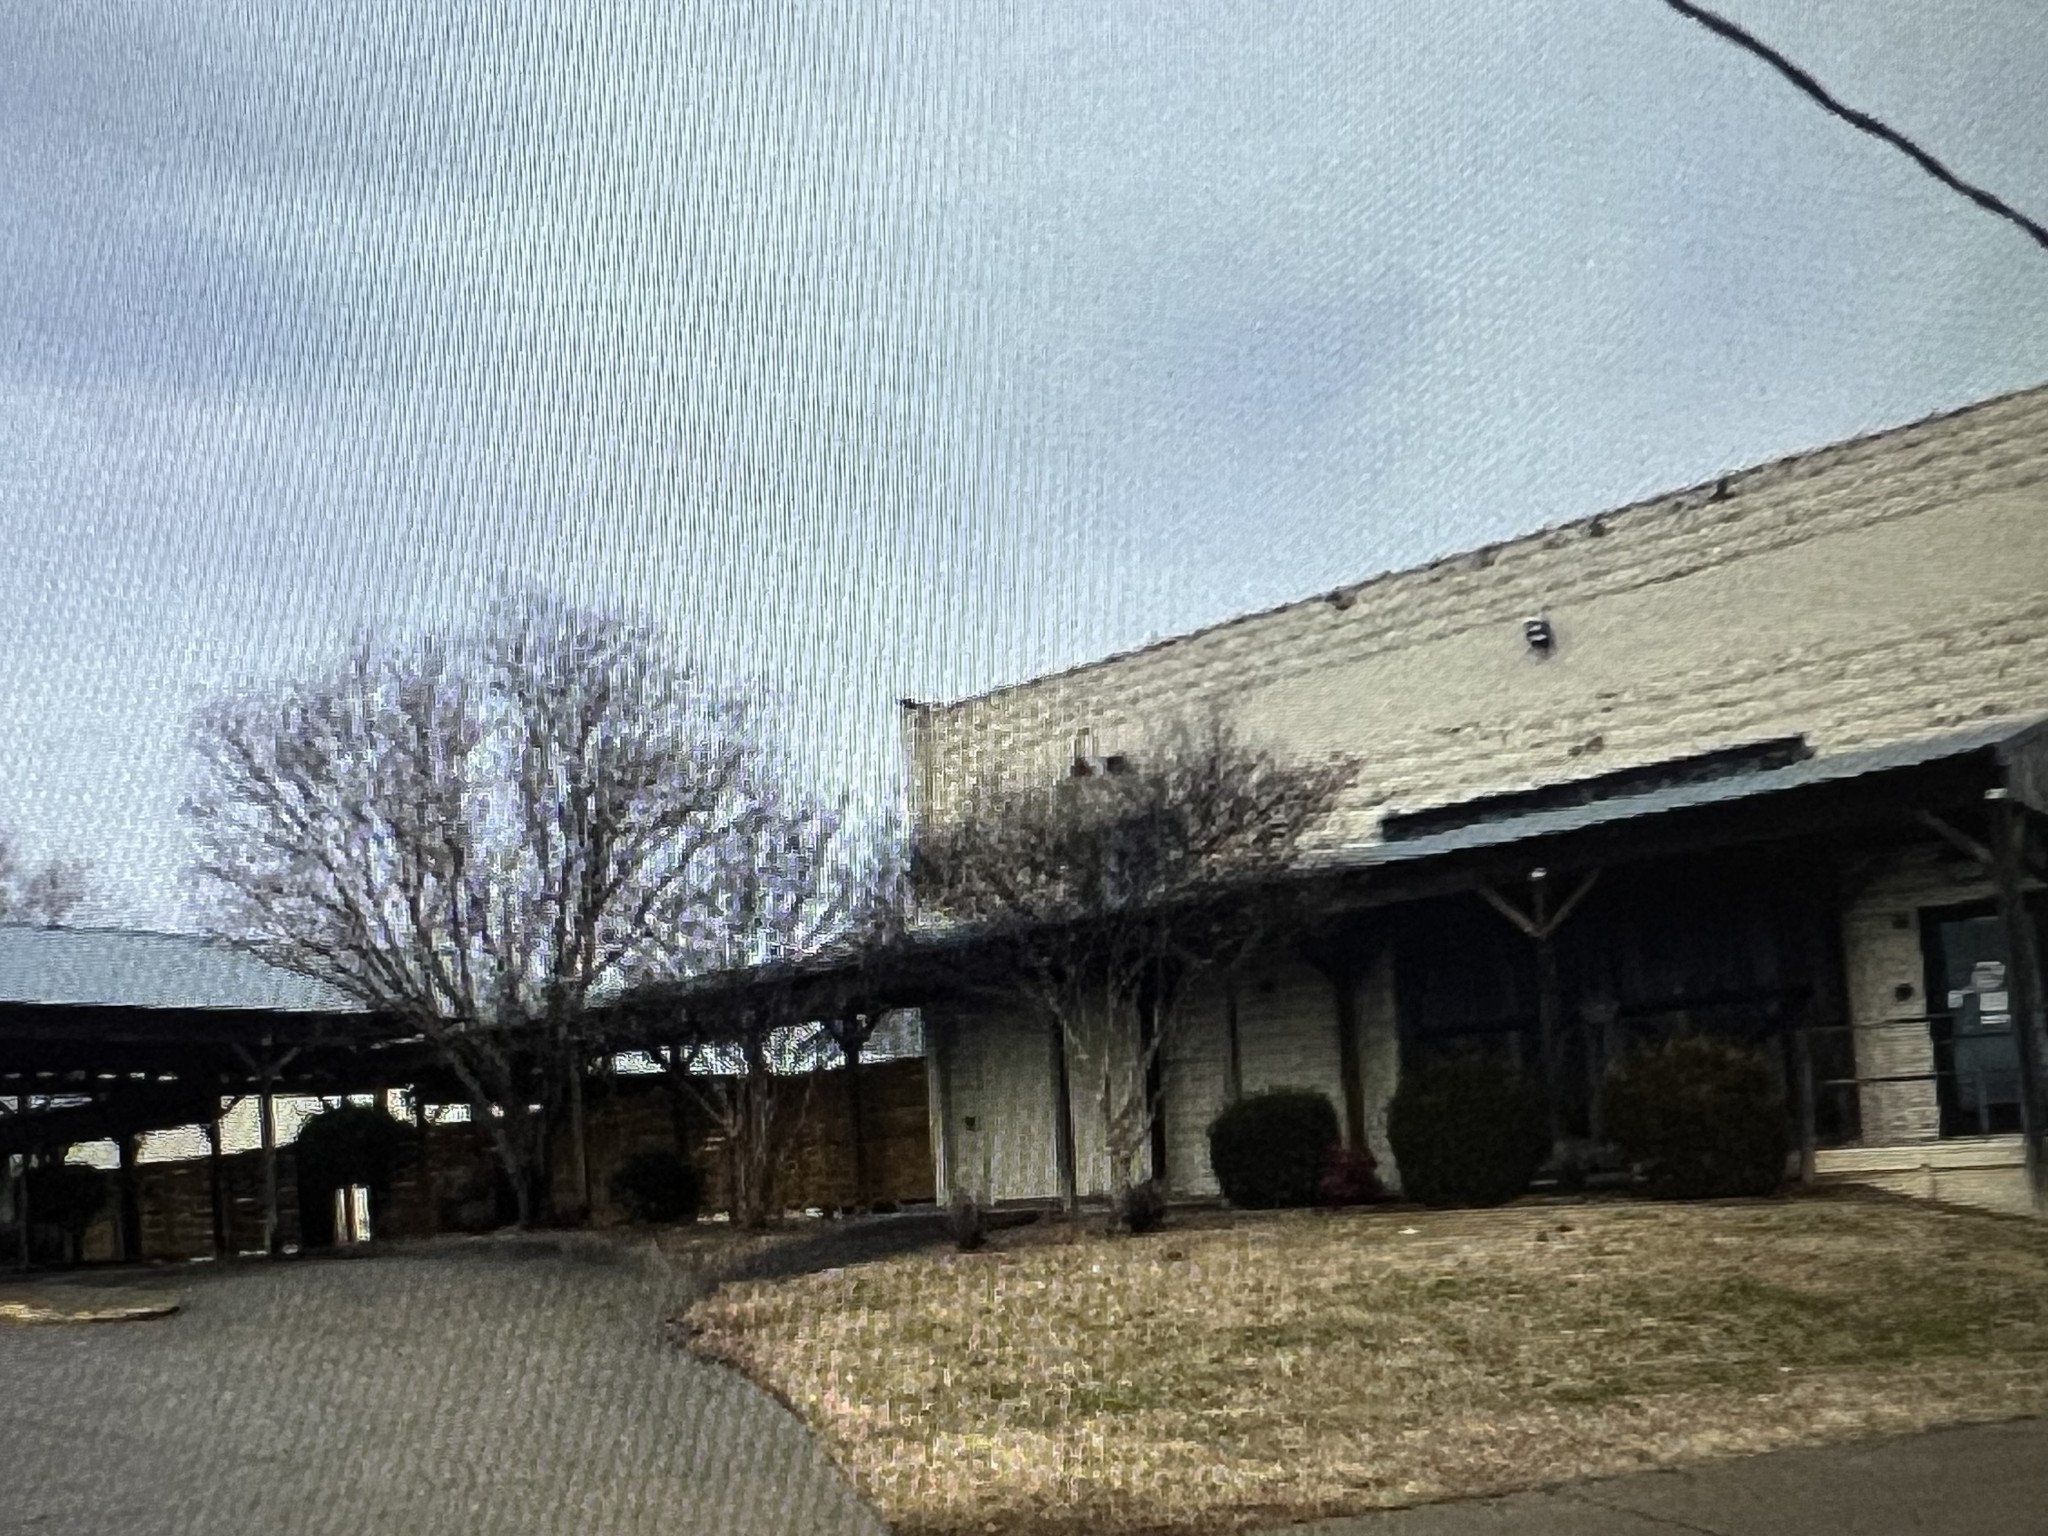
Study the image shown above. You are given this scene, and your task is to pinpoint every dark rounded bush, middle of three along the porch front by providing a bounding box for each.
[1386,1057,1550,1206]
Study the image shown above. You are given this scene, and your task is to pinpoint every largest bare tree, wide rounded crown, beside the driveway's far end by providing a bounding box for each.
[186,594,770,1221]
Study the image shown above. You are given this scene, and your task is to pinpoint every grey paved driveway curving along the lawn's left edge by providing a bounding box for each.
[0,1239,883,1536]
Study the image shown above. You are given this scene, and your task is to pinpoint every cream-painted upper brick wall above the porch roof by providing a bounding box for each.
[905,389,2048,840]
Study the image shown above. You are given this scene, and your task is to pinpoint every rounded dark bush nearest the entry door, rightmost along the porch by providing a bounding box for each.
[1608,1034,1792,1200]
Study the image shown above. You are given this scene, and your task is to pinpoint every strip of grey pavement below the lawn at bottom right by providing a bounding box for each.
[1286,1419,2048,1536]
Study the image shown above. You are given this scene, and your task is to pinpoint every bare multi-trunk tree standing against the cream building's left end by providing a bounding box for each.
[913,717,1356,1210]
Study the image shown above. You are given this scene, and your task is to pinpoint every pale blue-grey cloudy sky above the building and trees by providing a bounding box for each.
[0,0,2048,928]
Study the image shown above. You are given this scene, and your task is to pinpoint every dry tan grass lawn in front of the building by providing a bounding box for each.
[686,1196,2048,1536]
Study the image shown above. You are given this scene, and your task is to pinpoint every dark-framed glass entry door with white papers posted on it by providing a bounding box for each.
[1923,911,2019,1137]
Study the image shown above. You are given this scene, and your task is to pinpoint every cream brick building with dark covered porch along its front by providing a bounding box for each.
[903,376,2048,1208]
